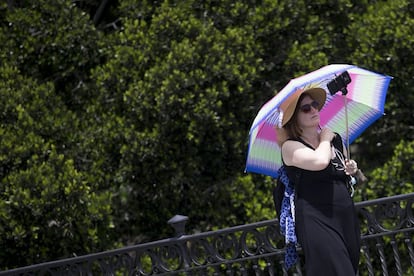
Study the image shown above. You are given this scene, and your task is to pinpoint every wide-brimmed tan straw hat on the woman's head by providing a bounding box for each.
[280,87,326,127]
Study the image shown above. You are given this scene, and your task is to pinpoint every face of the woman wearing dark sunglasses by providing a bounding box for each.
[298,95,320,128]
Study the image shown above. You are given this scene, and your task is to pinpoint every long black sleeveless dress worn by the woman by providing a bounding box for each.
[286,134,360,276]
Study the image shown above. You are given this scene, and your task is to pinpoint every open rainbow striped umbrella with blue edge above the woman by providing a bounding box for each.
[246,64,392,177]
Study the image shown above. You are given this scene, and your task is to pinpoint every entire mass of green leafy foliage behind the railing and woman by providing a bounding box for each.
[0,0,414,268]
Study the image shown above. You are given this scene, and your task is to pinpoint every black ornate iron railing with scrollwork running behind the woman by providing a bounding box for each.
[0,193,414,276]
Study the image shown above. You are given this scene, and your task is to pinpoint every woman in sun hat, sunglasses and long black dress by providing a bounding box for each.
[281,88,360,276]
